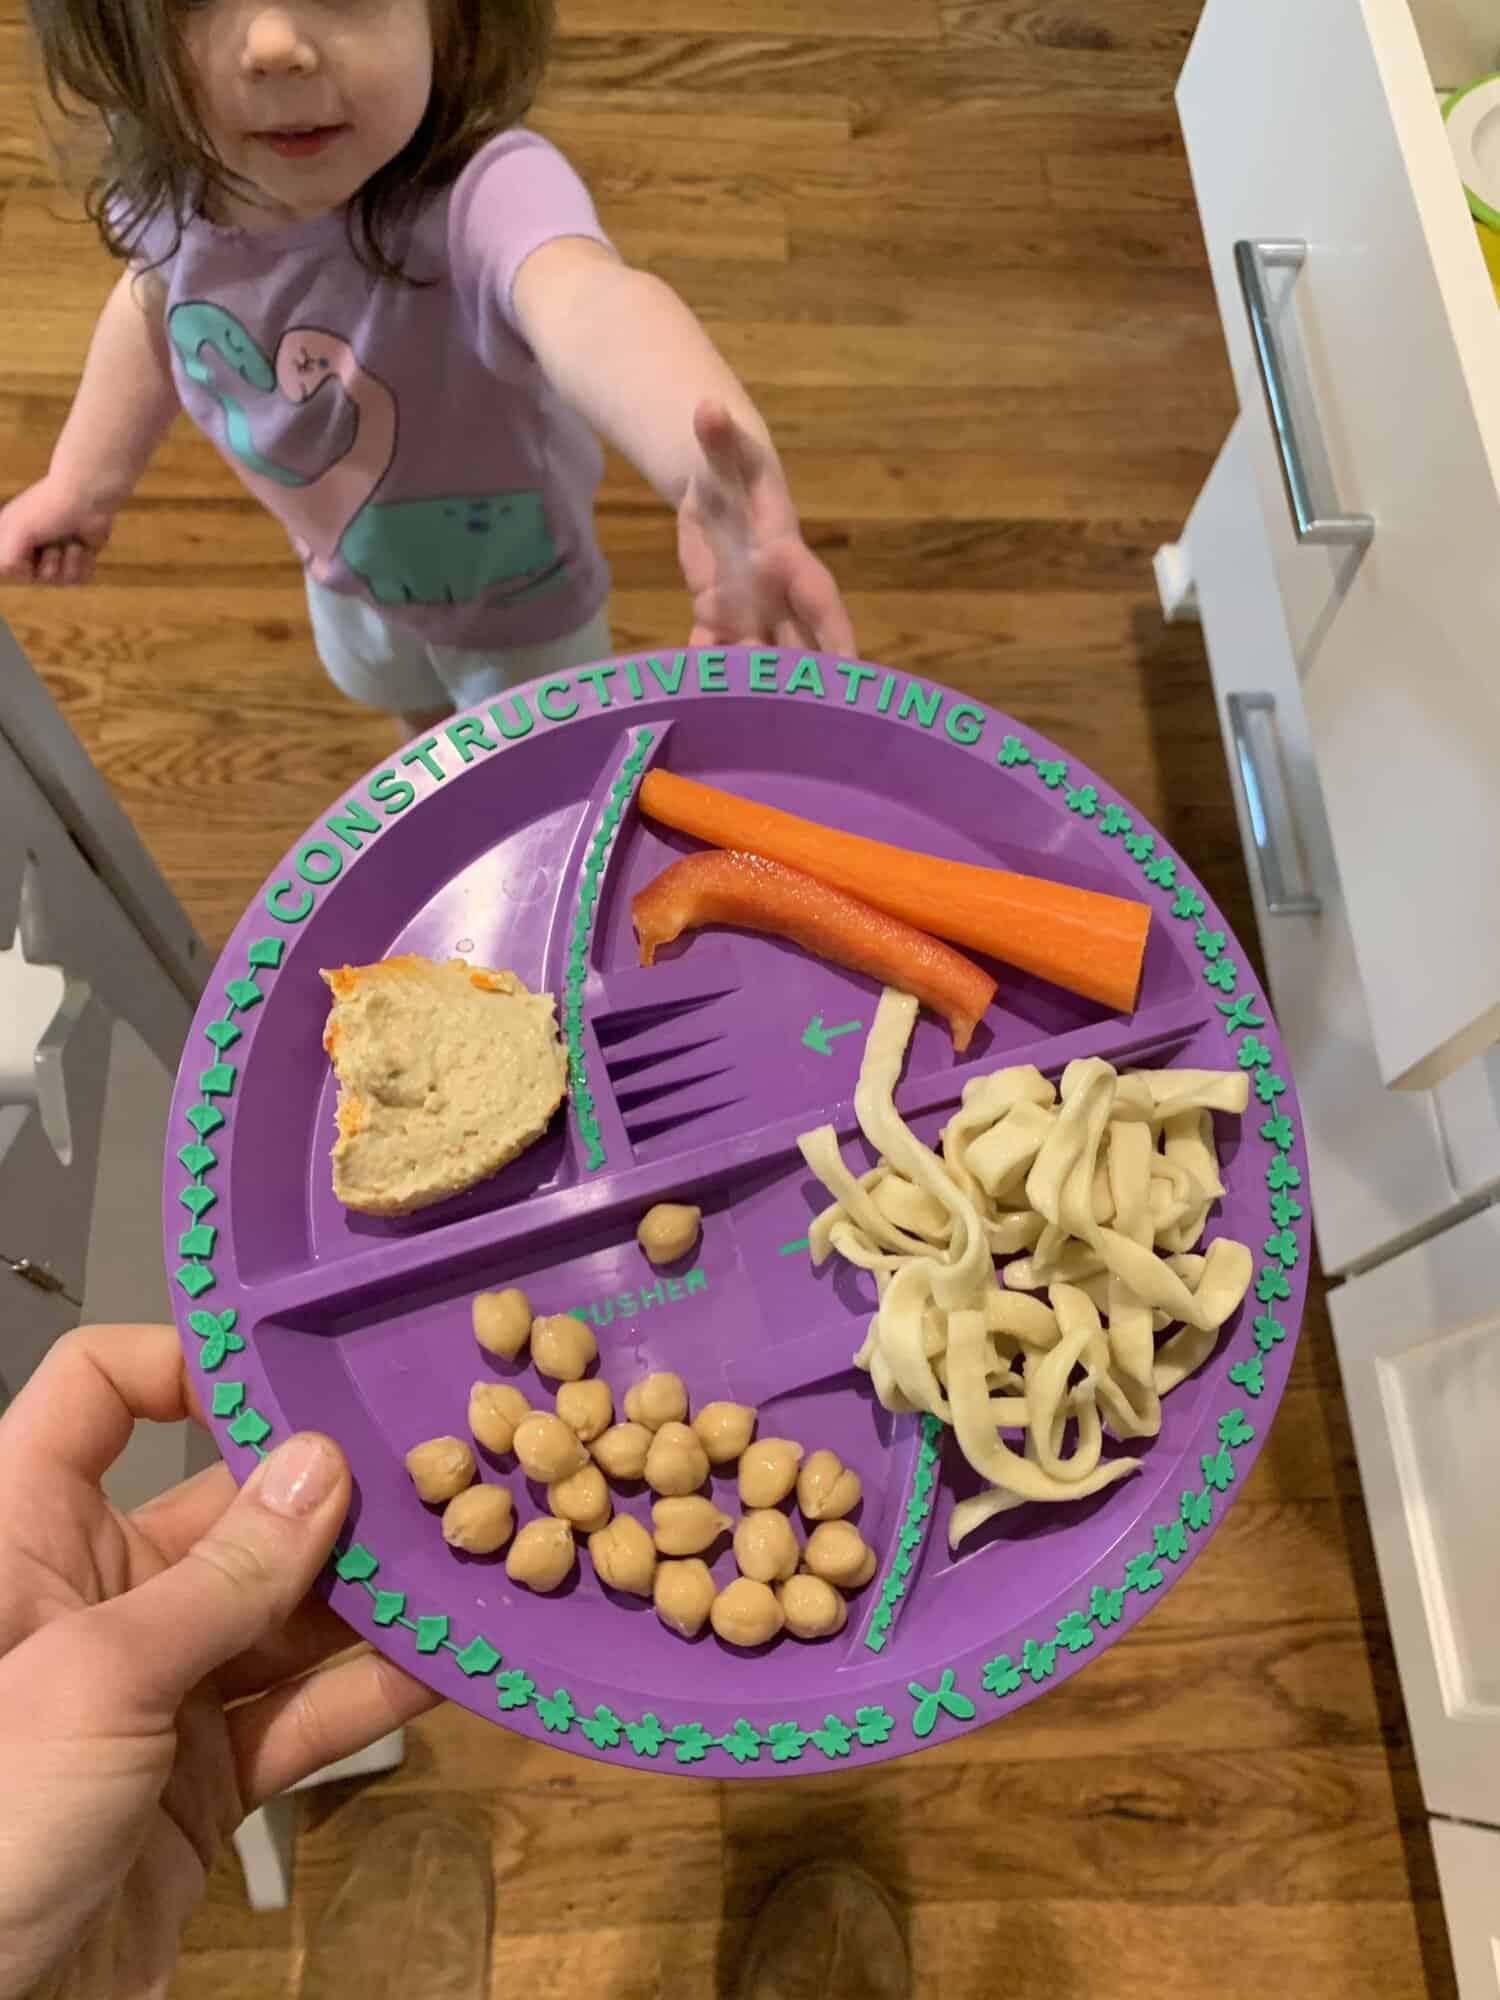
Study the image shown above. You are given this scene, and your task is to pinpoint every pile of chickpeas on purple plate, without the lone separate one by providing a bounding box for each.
[406,1208,876,1646]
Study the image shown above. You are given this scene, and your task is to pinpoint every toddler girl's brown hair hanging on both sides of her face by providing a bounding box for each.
[30,0,554,278]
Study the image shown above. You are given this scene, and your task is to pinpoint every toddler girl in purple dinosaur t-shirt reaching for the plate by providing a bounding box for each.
[0,0,852,730]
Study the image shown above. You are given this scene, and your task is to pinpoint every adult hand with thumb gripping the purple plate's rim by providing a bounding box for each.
[0,1326,436,2000]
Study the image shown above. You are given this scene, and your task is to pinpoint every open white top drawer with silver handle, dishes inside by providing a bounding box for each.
[1178,0,1500,1088]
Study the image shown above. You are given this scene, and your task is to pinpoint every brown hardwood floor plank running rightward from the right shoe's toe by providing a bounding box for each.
[724,1744,1432,1904]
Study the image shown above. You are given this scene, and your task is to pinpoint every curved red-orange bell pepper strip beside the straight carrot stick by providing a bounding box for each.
[630,852,994,1050]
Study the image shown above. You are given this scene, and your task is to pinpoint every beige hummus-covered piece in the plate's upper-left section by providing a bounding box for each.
[322,954,568,1216]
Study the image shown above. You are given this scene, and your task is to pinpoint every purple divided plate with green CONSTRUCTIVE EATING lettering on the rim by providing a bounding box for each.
[162,648,1308,1776]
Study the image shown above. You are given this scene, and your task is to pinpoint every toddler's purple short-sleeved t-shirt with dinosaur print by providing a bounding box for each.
[136,130,610,650]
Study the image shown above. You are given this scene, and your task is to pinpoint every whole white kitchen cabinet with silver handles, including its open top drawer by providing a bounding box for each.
[1158,0,1500,2000]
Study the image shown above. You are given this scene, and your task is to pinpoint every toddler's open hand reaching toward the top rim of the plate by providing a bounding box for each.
[680,402,854,654]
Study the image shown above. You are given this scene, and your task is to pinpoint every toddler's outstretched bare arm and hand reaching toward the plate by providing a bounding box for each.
[512,236,854,652]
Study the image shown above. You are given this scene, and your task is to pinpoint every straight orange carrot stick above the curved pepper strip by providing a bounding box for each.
[640,768,1150,1014]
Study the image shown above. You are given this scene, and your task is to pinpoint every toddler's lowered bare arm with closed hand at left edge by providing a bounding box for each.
[0,270,178,584]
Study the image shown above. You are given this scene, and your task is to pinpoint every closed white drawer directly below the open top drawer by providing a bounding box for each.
[1182,418,1472,1272]
